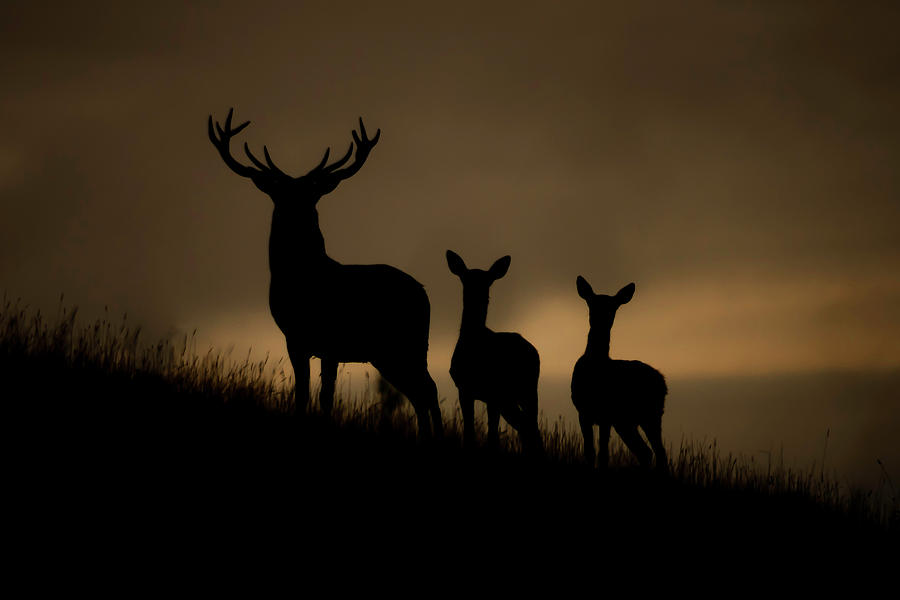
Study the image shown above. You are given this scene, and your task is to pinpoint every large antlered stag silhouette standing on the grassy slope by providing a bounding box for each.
[209,109,443,436]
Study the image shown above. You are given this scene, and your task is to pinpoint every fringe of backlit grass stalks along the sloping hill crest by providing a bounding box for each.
[0,297,900,528]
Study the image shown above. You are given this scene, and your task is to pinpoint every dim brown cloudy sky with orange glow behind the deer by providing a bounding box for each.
[0,1,900,394]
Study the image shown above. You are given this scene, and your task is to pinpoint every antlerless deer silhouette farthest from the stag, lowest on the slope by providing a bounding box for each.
[572,276,668,472]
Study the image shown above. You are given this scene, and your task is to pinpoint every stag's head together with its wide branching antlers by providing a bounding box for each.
[209,108,381,208]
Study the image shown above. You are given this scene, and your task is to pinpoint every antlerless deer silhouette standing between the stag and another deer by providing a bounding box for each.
[447,250,542,453]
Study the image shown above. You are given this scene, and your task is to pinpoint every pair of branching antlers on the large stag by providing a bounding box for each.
[209,108,381,185]
